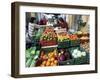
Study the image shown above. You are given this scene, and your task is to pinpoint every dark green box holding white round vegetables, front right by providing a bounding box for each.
[69,47,90,65]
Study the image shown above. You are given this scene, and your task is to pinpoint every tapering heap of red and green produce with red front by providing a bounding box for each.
[40,27,57,46]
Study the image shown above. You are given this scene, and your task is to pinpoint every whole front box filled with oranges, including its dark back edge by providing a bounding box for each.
[36,48,58,67]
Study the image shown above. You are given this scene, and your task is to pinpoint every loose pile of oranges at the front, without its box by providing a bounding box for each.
[40,49,58,67]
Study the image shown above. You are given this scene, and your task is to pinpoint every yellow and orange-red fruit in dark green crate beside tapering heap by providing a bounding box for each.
[57,32,80,48]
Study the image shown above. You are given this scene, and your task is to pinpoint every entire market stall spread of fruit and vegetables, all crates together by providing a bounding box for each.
[25,27,89,67]
